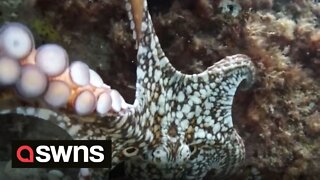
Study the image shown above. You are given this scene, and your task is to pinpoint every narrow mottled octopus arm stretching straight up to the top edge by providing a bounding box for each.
[125,0,177,111]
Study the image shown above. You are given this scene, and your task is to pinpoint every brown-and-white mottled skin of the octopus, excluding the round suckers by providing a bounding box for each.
[0,0,255,179]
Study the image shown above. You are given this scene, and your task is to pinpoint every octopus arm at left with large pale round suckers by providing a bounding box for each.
[0,20,151,170]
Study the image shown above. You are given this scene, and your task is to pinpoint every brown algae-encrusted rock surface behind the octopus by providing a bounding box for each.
[0,0,320,179]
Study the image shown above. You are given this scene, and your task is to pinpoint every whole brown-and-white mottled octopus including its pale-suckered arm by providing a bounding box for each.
[0,0,255,179]
